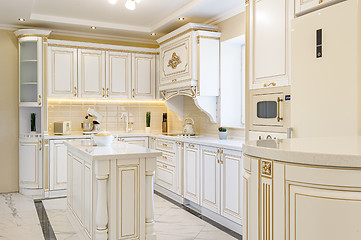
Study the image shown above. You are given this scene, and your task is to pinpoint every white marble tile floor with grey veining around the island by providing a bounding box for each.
[0,193,241,240]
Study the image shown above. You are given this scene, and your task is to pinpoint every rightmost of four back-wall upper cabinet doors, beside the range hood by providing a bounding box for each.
[132,54,155,99]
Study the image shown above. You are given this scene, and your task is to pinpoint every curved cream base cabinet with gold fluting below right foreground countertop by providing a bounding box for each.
[243,156,361,240]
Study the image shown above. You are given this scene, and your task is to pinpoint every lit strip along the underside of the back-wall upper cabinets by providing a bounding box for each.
[48,98,164,104]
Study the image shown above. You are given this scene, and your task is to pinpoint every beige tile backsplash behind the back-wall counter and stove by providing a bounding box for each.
[48,97,244,138]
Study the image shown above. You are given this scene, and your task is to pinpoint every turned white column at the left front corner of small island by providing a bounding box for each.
[95,160,109,240]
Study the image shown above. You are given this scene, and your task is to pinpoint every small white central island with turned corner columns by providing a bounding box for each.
[66,140,162,240]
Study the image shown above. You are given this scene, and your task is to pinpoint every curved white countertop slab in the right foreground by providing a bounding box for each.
[243,136,361,168]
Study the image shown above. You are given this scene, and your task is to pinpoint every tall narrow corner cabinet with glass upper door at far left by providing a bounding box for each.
[15,29,50,195]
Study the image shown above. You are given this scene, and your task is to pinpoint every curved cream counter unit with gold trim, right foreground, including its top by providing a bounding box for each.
[243,137,361,240]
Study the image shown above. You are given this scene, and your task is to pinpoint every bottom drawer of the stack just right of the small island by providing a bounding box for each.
[155,162,176,191]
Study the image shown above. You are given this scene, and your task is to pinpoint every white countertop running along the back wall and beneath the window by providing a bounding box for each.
[44,132,245,151]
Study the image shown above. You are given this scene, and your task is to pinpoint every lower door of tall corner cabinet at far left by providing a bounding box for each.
[19,139,42,188]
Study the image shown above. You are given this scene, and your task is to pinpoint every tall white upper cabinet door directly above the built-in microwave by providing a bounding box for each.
[248,0,290,89]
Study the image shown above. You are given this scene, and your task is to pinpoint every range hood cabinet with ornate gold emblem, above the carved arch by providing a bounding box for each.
[157,23,221,96]
